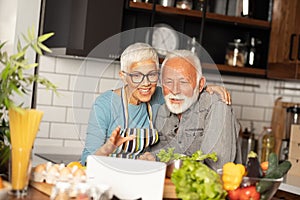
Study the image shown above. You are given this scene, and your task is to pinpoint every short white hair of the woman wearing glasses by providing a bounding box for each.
[120,42,159,71]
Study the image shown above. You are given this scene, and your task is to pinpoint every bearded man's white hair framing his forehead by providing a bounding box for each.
[161,49,202,83]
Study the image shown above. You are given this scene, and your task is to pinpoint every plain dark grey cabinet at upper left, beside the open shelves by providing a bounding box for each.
[42,0,124,58]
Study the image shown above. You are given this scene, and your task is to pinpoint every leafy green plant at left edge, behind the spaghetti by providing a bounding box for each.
[0,28,57,177]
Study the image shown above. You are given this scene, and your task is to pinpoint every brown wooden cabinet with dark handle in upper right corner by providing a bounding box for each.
[267,0,300,80]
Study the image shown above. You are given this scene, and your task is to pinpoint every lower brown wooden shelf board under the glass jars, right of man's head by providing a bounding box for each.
[203,63,267,77]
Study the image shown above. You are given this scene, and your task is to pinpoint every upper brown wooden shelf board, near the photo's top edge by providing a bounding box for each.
[129,1,271,29]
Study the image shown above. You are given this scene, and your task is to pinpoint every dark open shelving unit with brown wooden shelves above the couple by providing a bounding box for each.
[122,0,272,77]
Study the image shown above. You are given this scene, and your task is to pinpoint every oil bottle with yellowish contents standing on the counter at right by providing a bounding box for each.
[260,127,275,162]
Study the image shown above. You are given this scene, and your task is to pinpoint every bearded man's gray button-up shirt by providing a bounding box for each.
[151,91,241,169]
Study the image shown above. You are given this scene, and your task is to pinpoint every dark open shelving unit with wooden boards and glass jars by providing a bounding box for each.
[122,0,272,77]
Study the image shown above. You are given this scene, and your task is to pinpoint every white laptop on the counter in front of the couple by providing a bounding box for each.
[86,155,166,200]
